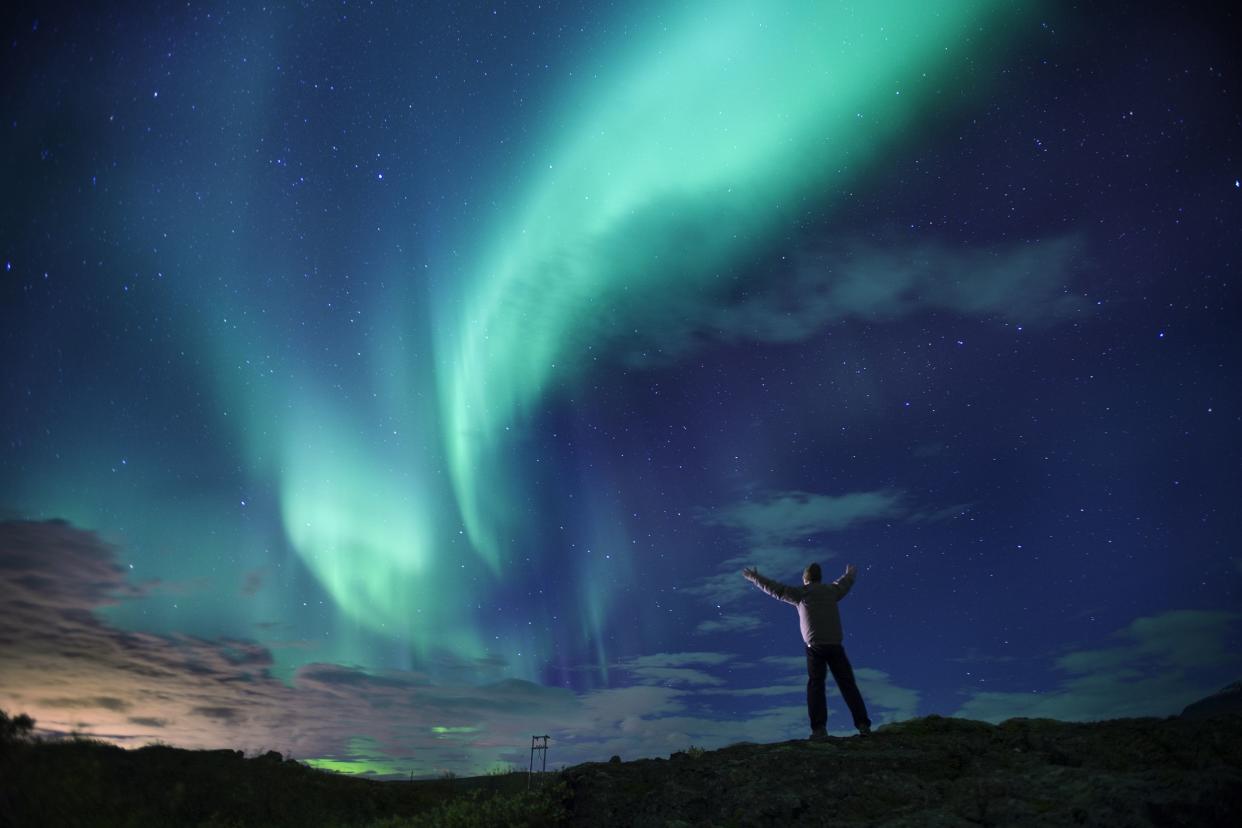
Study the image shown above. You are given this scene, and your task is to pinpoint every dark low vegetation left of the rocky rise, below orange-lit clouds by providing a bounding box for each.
[0,711,566,828]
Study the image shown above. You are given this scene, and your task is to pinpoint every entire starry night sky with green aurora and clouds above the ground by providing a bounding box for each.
[0,0,1242,775]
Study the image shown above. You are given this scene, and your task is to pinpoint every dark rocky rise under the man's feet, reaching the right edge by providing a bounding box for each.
[565,715,1242,827]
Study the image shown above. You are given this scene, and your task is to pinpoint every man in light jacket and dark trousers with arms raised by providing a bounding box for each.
[741,564,871,741]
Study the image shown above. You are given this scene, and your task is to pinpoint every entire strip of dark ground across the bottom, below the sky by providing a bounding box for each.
[0,716,1242,828]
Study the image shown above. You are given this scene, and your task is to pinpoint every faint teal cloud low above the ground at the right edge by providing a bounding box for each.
[955,610,1242,721]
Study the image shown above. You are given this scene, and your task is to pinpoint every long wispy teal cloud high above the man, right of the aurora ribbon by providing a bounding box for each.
[619,233,1087,365]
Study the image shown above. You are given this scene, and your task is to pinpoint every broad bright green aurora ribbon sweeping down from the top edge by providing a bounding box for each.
[437,0,1031,576]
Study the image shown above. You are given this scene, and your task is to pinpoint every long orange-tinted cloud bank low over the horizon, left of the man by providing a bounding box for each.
[0,523,844,776]
